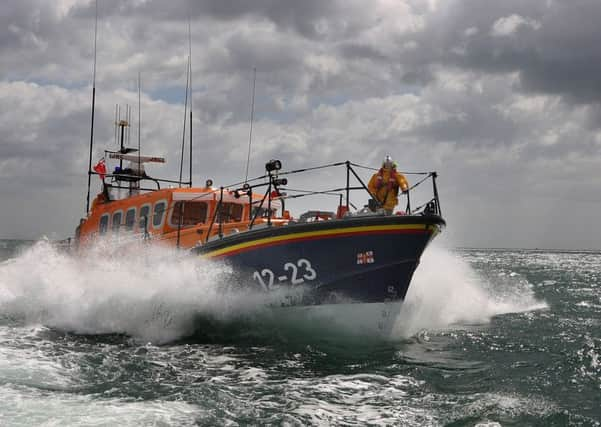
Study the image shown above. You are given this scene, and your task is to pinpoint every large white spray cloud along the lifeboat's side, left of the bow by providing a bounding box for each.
[0,241,278,343]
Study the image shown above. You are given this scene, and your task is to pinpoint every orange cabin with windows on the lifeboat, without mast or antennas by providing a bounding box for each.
[76,187,288,248]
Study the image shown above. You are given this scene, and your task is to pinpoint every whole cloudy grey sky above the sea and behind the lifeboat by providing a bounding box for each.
[0,0,601,248]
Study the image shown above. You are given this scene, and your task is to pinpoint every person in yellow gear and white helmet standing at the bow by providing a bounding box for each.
[367,156,409,215]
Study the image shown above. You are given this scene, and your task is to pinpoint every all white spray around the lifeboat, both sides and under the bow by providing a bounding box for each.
[0,241,545,343]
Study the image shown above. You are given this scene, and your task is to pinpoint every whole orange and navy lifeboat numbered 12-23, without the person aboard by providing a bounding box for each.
[74,123,445,305]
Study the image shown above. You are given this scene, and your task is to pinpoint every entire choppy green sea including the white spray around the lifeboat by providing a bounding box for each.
[0,241,601,426]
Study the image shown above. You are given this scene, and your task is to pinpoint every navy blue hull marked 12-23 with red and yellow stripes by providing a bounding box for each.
[197,216,444,305]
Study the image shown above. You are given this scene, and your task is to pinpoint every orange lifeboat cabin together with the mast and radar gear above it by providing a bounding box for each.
[75,107,289,249]
